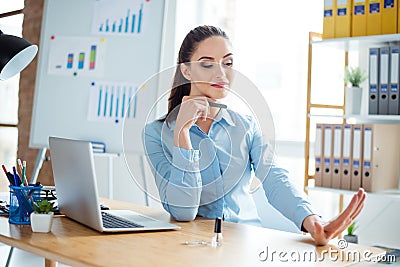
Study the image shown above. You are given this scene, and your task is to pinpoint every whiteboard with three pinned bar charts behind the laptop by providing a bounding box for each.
[30,0,173,153]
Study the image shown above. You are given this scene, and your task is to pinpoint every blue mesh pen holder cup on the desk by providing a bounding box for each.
[8,185,43,224]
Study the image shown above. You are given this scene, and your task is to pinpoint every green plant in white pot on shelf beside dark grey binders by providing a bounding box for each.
[344,67,368,114]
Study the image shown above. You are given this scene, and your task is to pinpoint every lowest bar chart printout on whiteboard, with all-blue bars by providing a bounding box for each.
[88,82,138,123]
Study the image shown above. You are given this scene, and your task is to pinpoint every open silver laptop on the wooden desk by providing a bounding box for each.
[49,137,180,232]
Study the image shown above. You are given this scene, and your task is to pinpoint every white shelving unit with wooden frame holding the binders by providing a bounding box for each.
[304,32,400,212]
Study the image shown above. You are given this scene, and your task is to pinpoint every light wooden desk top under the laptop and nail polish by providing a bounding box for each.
[0,200,384,267]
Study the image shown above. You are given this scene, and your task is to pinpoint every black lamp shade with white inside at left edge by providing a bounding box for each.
[0,30,38,80]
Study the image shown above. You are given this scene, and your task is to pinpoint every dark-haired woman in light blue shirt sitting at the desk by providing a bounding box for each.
[144,26,366,245]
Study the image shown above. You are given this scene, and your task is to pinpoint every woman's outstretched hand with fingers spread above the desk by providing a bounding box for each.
[303,188,366,245]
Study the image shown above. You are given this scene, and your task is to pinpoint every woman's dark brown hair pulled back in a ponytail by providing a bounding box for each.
[160,25,229,122]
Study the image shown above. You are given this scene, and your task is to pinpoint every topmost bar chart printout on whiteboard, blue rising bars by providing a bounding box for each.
[92,0,150,35]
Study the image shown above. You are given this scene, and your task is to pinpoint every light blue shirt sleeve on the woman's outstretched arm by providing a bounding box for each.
[249,117,315,230]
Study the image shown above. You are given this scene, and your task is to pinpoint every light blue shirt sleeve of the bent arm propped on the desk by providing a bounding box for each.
[143,122,202,221]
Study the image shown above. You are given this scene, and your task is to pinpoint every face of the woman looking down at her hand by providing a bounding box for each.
[181,36,233,99]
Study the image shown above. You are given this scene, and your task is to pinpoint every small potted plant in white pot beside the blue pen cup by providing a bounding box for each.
[31,199,54,233]
